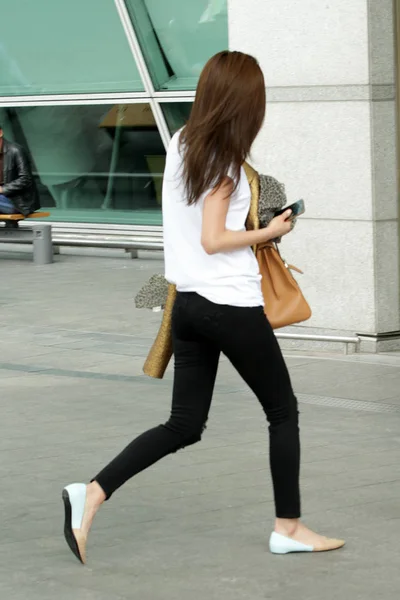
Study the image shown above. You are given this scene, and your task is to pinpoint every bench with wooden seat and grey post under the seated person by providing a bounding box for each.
[0,212,53,265]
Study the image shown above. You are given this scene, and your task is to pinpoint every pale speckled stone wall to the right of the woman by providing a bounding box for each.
[228,0,400,333]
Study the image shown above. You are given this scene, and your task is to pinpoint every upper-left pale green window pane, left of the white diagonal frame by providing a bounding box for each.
[0,0,143,96]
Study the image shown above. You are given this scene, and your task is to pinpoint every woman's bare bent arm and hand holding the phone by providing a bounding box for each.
[201,177,291,254]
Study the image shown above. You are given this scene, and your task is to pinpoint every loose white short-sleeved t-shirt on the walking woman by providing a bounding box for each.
[162,132,264,307]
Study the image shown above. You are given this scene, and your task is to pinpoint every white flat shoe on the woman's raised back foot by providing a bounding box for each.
[62,483,86,564]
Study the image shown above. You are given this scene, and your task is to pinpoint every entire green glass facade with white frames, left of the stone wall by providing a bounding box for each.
[0,0,228,226]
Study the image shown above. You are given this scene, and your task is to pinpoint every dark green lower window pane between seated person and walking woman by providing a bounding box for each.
[0,104,165,225]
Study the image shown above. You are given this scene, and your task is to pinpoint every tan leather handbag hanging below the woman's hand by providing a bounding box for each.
[257,242,311,329]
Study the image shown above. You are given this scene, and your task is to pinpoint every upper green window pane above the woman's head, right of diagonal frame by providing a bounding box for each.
[126,0,228,90]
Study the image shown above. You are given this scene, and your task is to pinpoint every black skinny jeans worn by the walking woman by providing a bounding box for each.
[95,293,300,519]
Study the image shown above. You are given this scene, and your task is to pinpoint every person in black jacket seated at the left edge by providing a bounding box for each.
[0,125,40,217]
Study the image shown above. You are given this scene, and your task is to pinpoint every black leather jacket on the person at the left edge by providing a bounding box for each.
[3,140,40,216]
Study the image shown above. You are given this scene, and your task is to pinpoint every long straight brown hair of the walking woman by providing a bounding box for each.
[180,51,265,204]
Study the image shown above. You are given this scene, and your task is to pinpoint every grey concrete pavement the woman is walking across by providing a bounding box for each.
[0,245,400,600]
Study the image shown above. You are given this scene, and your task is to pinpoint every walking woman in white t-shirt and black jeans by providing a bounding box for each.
[63,51,344,563]
